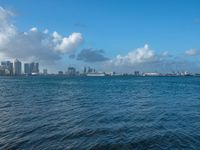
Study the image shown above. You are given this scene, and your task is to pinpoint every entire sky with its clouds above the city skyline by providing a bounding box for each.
[0,0,200,73]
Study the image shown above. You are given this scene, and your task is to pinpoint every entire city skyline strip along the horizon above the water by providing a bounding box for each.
[0,59,200,76]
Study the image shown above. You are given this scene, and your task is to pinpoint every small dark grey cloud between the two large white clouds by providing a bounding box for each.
[77,49,109,62]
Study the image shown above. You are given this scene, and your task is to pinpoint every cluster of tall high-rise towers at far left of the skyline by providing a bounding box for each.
[0,59,39,76]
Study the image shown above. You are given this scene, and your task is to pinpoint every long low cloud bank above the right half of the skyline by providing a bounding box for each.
[102,44,200,73]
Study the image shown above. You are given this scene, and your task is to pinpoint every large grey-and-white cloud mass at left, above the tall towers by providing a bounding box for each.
[0,7,83,61]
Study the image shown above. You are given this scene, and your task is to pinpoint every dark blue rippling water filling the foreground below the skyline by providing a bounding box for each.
[0,77,200,150]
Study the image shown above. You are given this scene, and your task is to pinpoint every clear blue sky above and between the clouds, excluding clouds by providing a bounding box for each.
[0,0,200,72]
